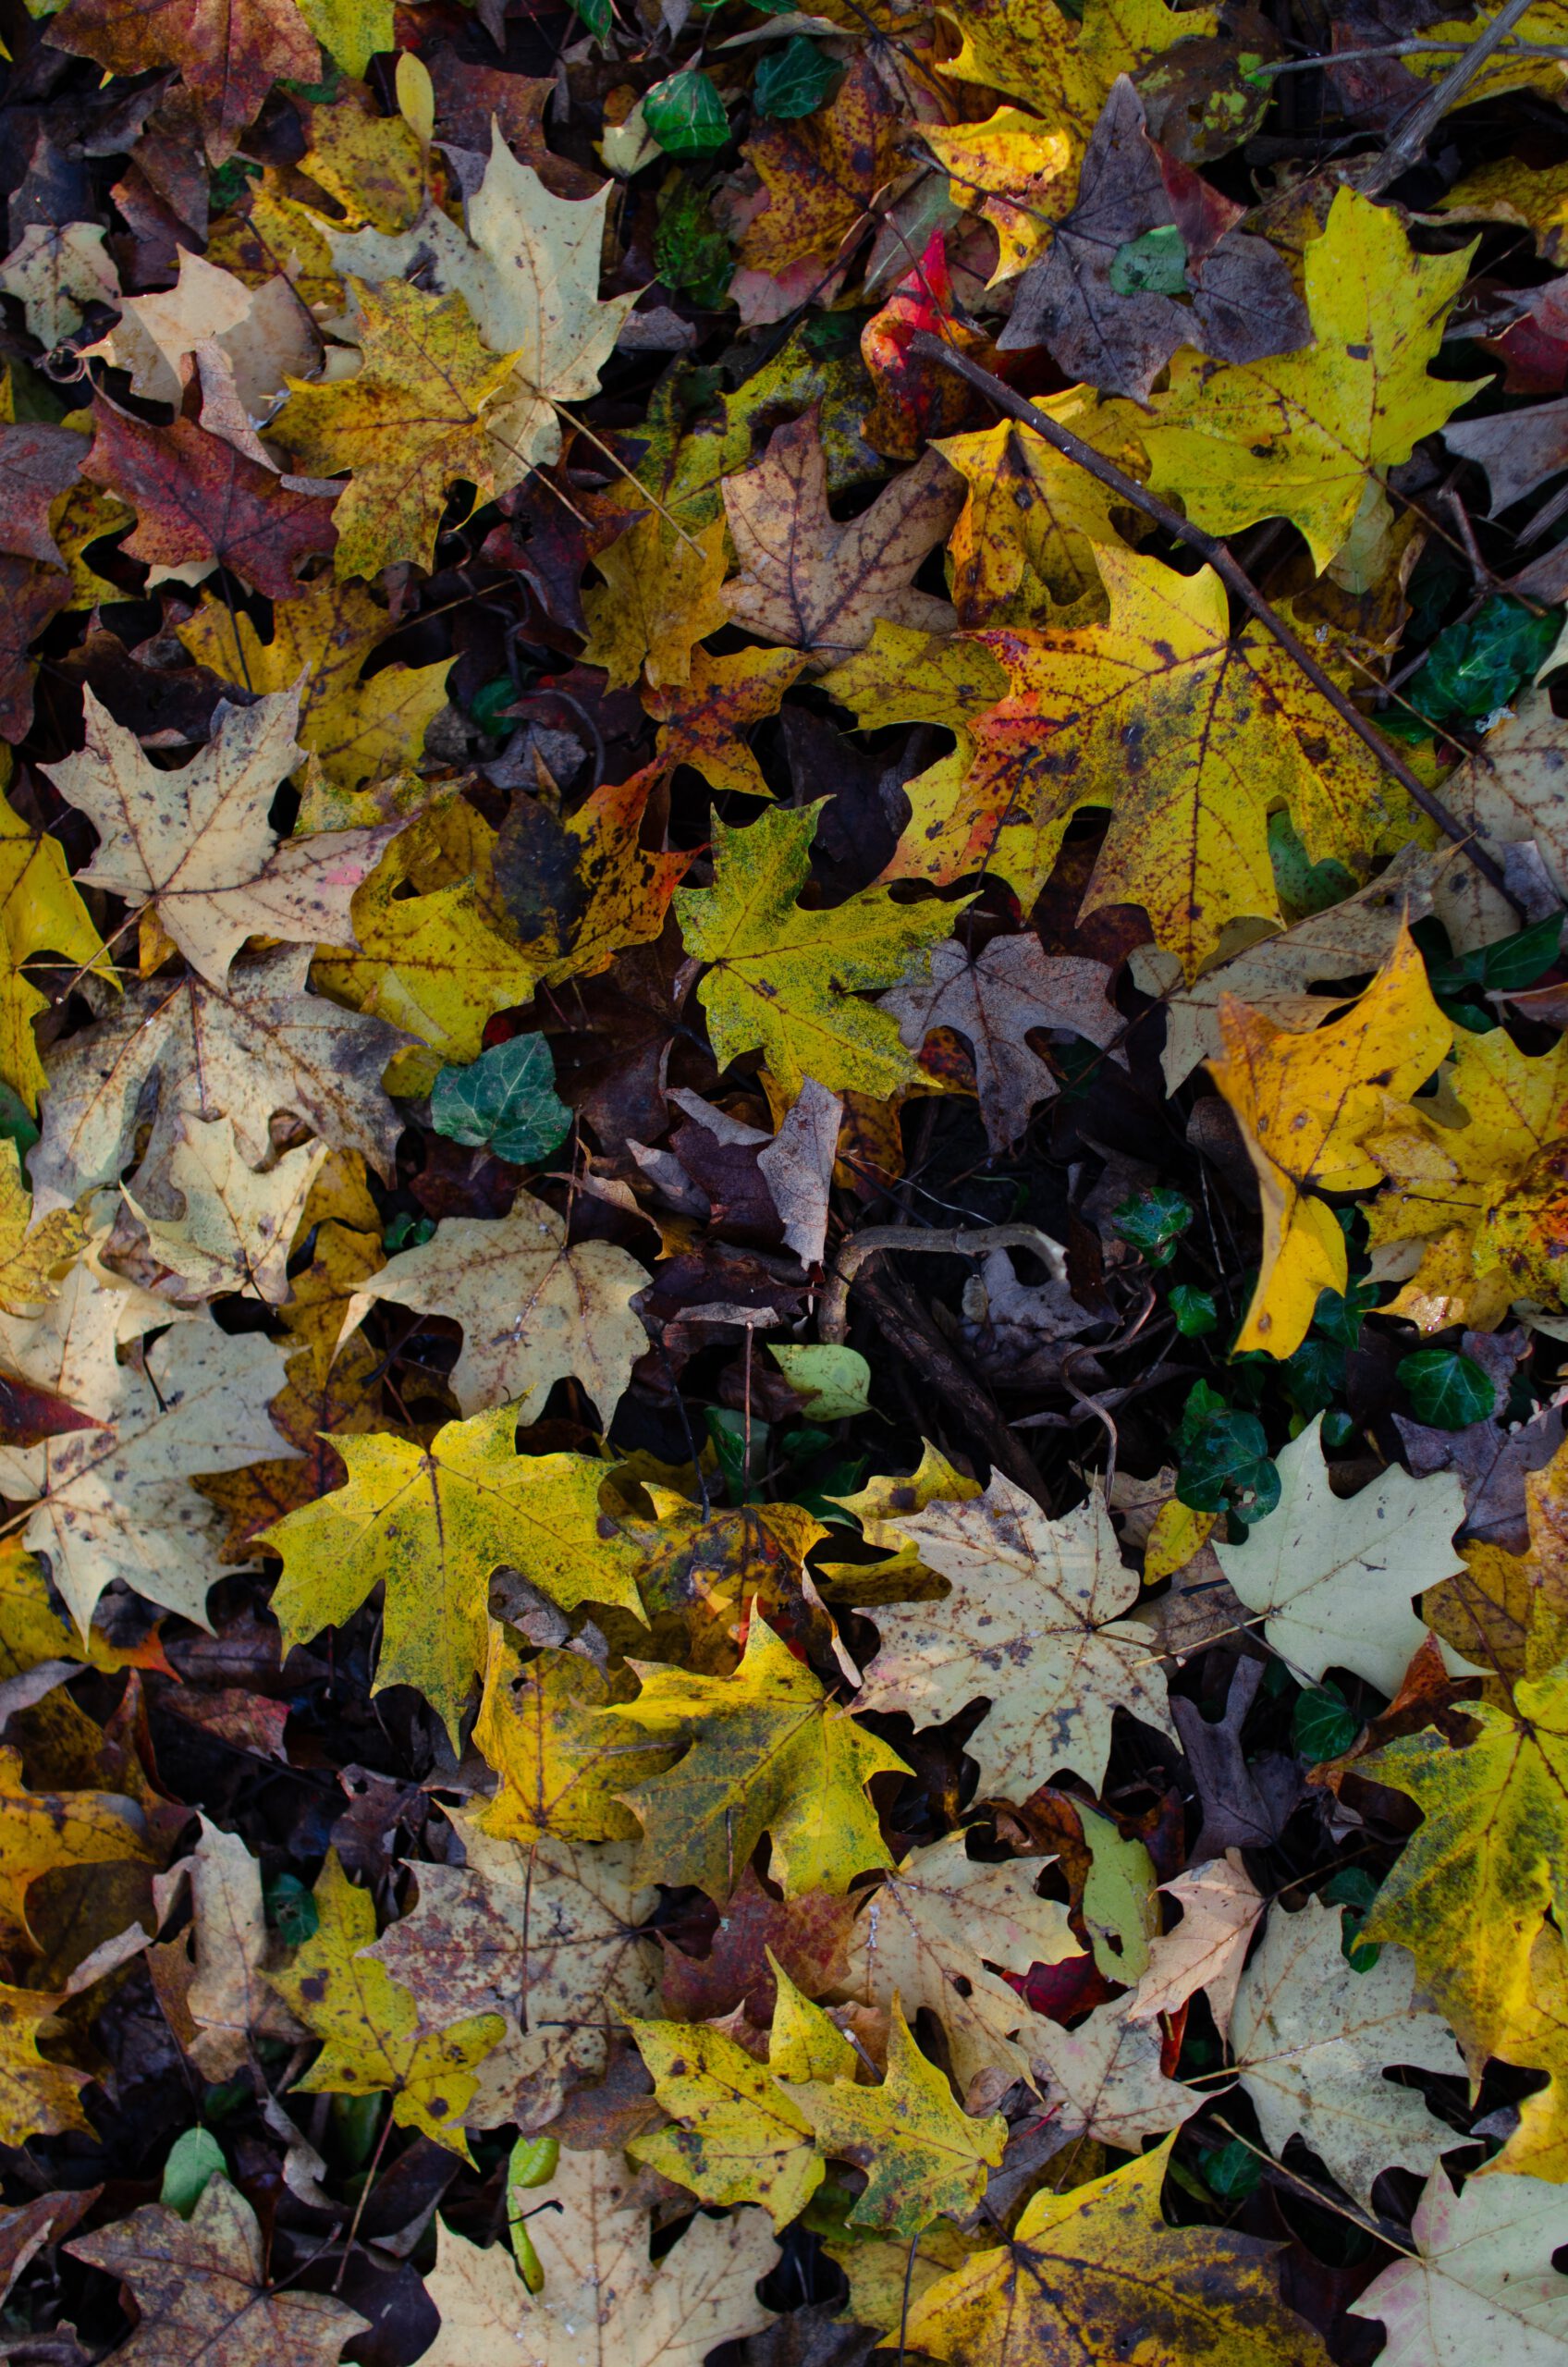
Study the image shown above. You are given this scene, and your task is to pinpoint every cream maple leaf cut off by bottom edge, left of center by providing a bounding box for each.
[419,2152,779,2367]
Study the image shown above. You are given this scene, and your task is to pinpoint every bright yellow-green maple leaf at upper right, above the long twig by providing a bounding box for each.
[1142,190,1474,573]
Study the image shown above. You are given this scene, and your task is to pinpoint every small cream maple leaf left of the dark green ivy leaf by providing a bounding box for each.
[127,1115,327,1306]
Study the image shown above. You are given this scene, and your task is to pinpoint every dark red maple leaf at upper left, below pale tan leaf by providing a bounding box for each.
[83,396,337,599]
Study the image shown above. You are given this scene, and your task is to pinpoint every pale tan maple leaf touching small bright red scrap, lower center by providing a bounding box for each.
[843,1832,1080,2109]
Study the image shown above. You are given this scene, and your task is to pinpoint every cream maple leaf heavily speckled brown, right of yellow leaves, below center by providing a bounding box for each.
[855,1472,1172,1801]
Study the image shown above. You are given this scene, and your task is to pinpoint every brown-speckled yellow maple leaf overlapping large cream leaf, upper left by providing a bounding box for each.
[275,279,514,575]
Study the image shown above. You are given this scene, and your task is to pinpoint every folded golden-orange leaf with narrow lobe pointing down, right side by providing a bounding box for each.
[1208,928,1452,1356]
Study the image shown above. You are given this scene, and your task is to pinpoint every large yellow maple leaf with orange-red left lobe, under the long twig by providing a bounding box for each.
[952,546,1386,977]
